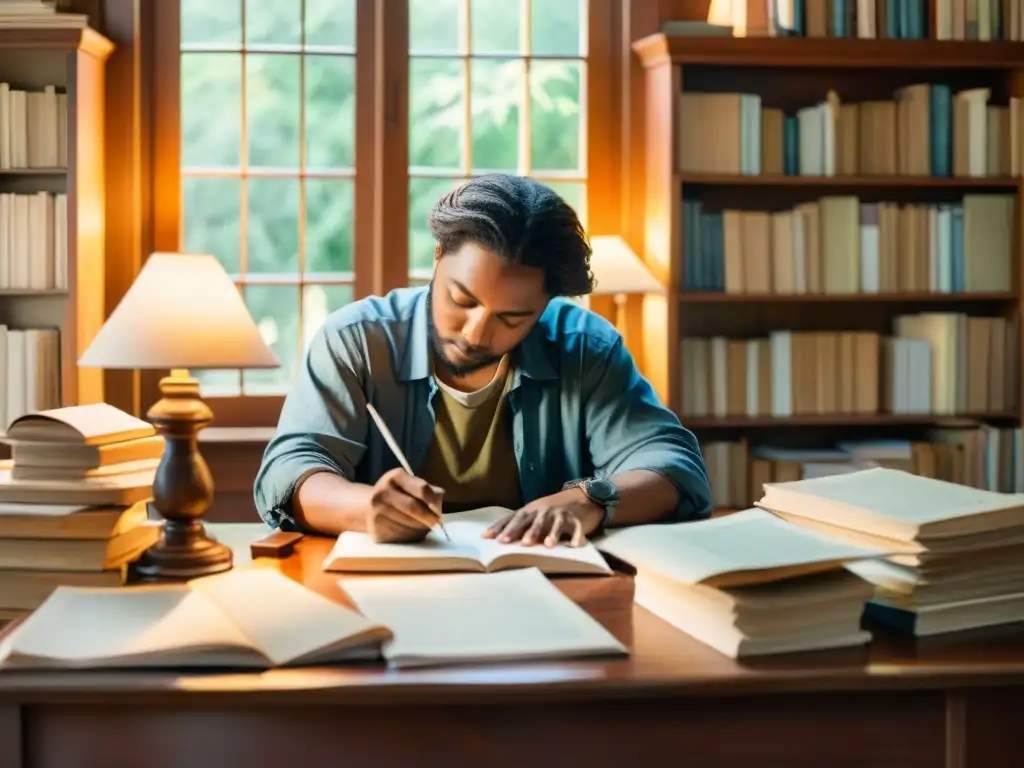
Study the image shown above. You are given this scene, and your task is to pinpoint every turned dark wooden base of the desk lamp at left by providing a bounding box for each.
[132,369,232,581]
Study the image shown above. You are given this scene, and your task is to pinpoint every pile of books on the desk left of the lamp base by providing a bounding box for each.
[0,403,164,621]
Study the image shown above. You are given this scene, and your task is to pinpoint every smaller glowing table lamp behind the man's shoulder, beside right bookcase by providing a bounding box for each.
[590,234,665,341]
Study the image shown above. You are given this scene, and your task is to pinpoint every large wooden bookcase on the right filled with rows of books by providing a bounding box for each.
[633,34,1024,506]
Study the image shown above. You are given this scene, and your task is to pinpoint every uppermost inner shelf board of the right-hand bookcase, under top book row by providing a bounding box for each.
[675,171,1021,189]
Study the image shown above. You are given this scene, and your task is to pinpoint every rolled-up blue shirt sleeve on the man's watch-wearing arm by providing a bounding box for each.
[584,338,712,522]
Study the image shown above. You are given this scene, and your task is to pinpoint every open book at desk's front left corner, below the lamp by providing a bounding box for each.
[0,568,391,669]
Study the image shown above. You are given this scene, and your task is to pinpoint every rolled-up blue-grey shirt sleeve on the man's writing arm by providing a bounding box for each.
[254,324,367,530]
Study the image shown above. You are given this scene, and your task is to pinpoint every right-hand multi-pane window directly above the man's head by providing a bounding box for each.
[409,0,589,284]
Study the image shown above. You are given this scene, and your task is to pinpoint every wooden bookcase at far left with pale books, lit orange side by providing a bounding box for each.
[0,26,113,430]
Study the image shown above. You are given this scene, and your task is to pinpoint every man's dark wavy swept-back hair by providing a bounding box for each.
[430,173,594,296]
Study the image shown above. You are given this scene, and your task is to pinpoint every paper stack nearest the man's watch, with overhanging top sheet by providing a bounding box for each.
[597,509,888,657]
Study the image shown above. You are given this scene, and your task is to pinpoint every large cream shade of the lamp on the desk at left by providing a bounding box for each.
[79,252,281,370]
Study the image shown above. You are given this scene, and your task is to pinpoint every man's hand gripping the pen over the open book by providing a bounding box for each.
[367,468,444,543]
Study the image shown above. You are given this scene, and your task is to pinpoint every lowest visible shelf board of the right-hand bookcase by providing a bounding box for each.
[679,413,1020,429]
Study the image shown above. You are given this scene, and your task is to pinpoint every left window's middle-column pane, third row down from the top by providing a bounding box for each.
[246,178,299,274]
